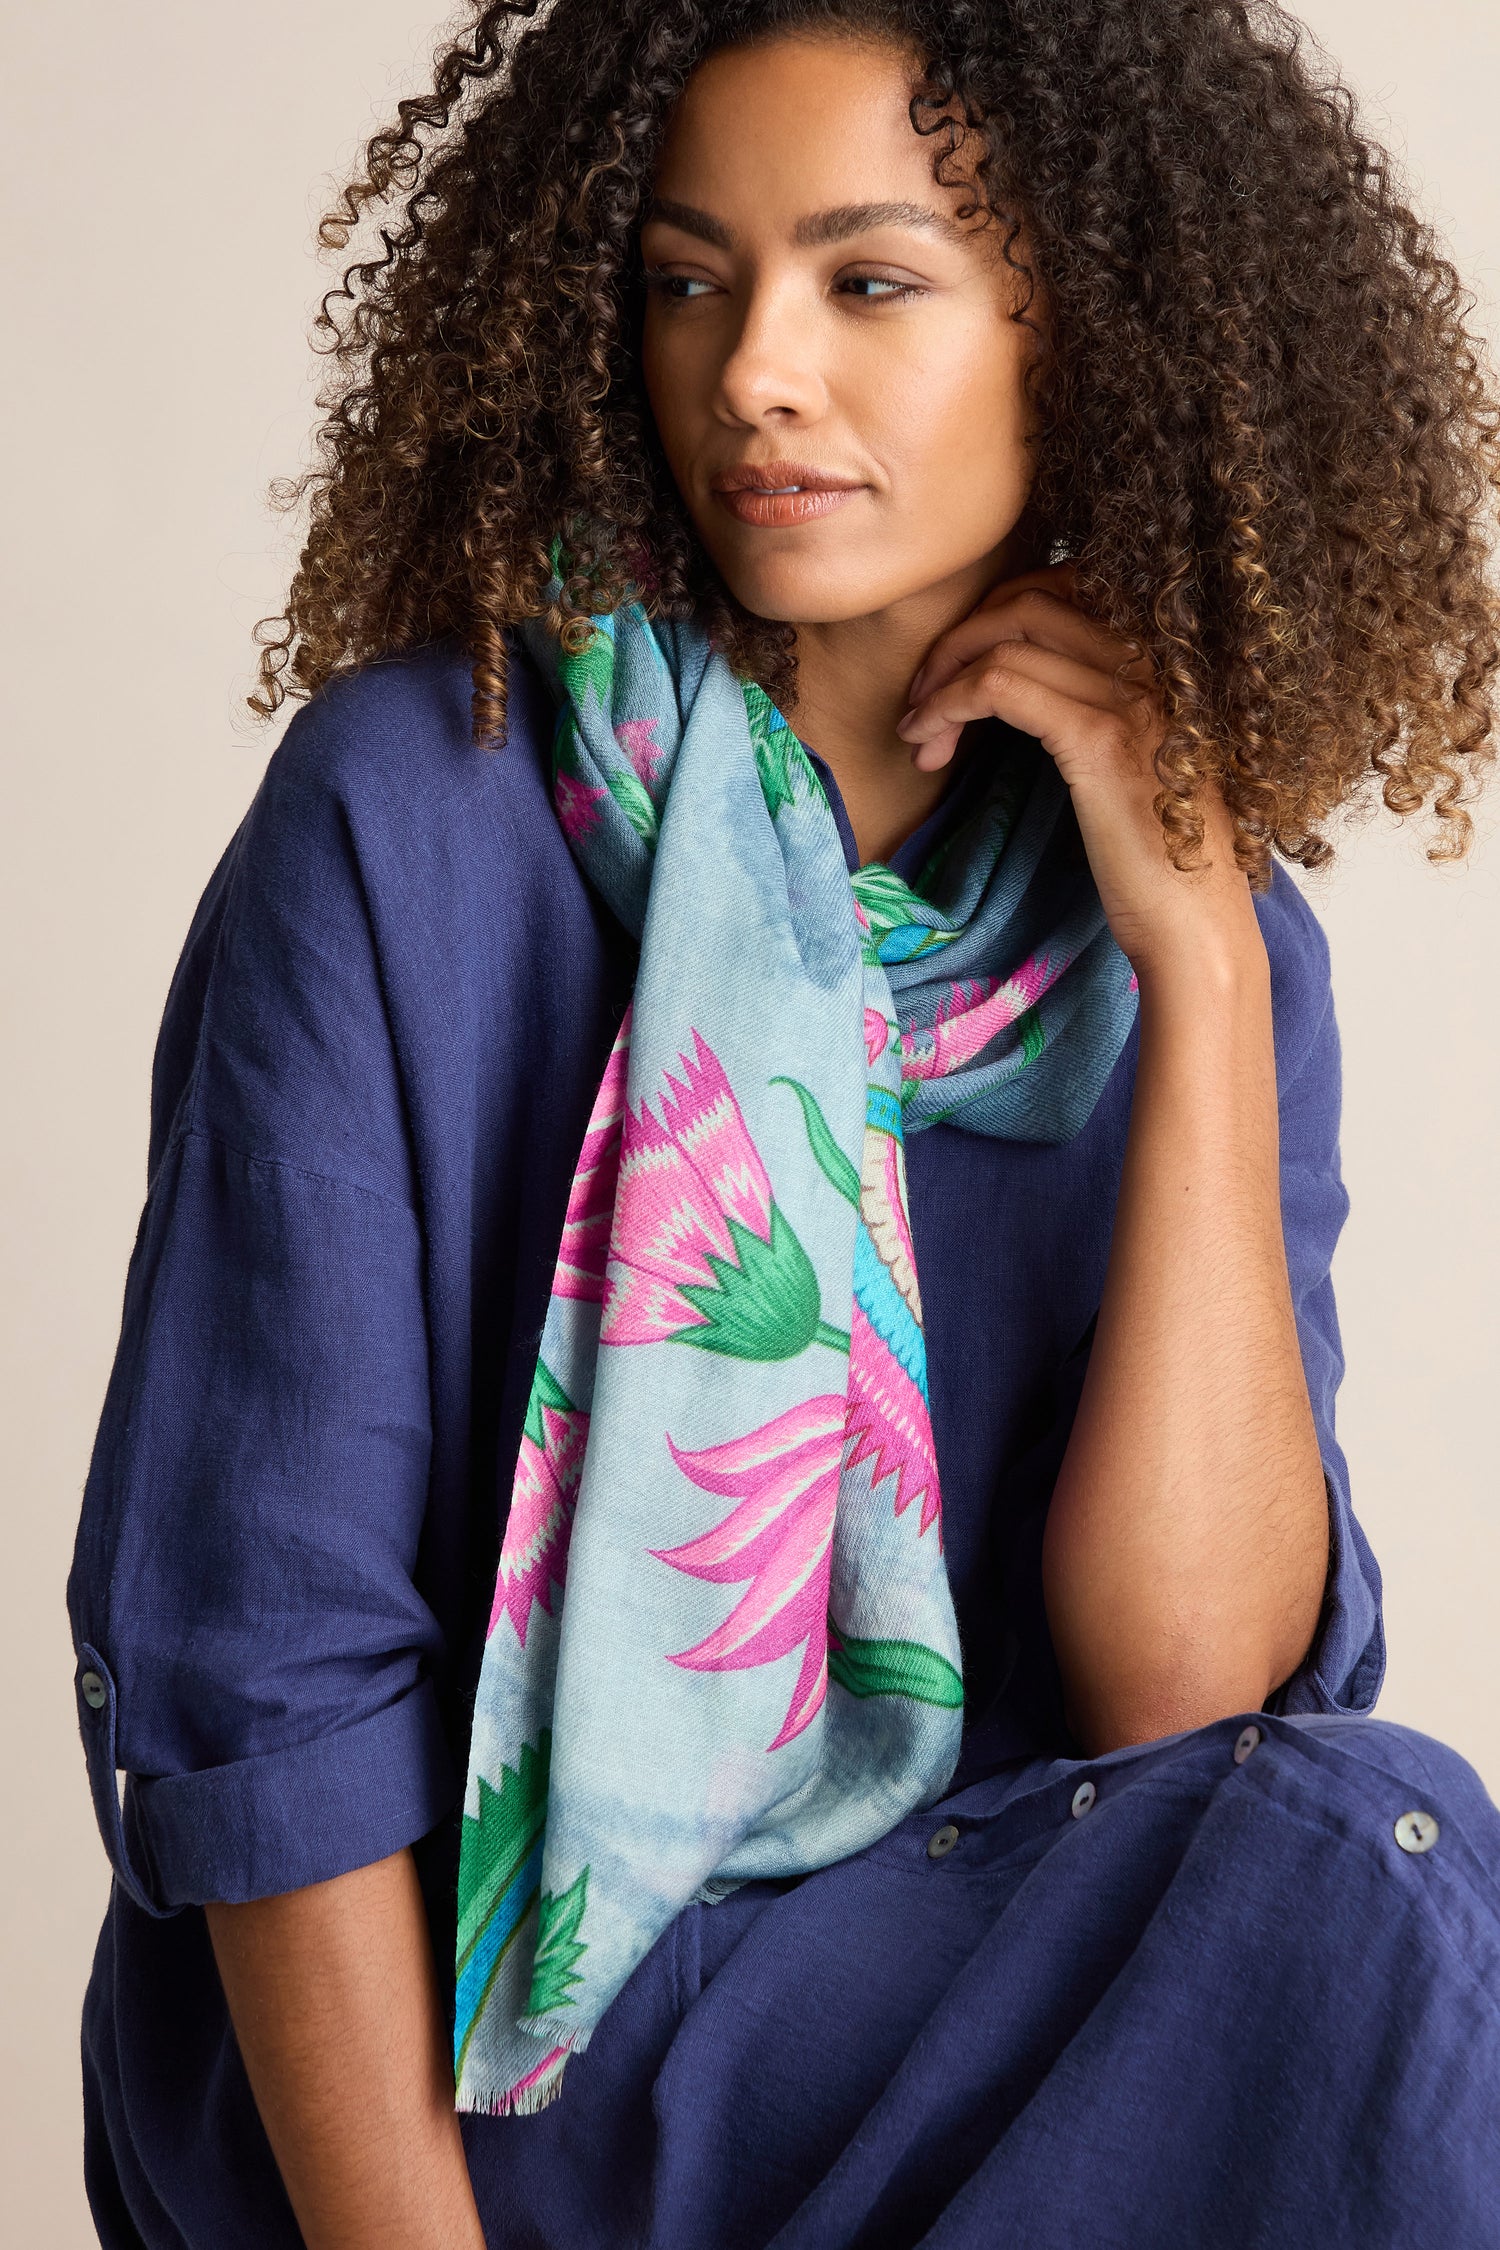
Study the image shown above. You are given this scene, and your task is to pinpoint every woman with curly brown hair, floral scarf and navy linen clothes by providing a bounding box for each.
[72,0,1500,2250]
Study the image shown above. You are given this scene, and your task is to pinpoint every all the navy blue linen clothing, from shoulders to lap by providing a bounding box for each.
[70,650,1500,2250]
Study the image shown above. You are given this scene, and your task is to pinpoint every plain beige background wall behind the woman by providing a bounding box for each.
[0,0,1500,2250]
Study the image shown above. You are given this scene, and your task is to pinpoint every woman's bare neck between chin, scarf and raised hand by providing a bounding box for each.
[792,549,1021,862]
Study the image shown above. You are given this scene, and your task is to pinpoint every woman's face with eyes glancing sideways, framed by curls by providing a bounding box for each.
[641,34,1034,623]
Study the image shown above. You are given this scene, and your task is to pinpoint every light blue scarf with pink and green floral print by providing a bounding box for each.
[454,605,1136,2113]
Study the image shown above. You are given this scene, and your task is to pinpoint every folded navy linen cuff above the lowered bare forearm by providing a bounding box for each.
[126,1681,459,1913]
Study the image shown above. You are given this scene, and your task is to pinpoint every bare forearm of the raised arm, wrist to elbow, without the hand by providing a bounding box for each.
[1043,918,1327,1751]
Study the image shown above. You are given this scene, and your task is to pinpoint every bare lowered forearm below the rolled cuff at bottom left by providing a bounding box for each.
[207,1852,484,2250]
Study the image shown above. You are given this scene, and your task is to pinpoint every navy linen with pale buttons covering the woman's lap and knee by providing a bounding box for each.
[468,1719,1500,2250]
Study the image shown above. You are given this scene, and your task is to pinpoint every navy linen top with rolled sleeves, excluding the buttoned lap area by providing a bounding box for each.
[70,650,1383,2243]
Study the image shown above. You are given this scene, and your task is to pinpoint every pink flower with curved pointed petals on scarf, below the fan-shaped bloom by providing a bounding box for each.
[657,1397,846,1751]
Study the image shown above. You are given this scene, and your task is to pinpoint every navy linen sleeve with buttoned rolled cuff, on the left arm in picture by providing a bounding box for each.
[70,711,457,1913]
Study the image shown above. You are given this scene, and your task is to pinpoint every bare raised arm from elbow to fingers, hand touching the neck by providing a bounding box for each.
[897,565,1329,1751]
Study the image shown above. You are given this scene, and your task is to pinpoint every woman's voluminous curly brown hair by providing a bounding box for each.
[252,0,1500,880]
